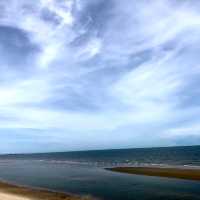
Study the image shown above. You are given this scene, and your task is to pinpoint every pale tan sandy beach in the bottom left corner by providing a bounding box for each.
[0,180,94,200]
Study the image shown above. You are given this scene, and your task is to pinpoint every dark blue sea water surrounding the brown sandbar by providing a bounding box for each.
[0,146,200,200]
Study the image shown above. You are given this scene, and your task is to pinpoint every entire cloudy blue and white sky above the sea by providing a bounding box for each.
[0,0,200,153]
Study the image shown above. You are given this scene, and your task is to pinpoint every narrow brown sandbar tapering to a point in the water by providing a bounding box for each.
[105,167,200,181]
